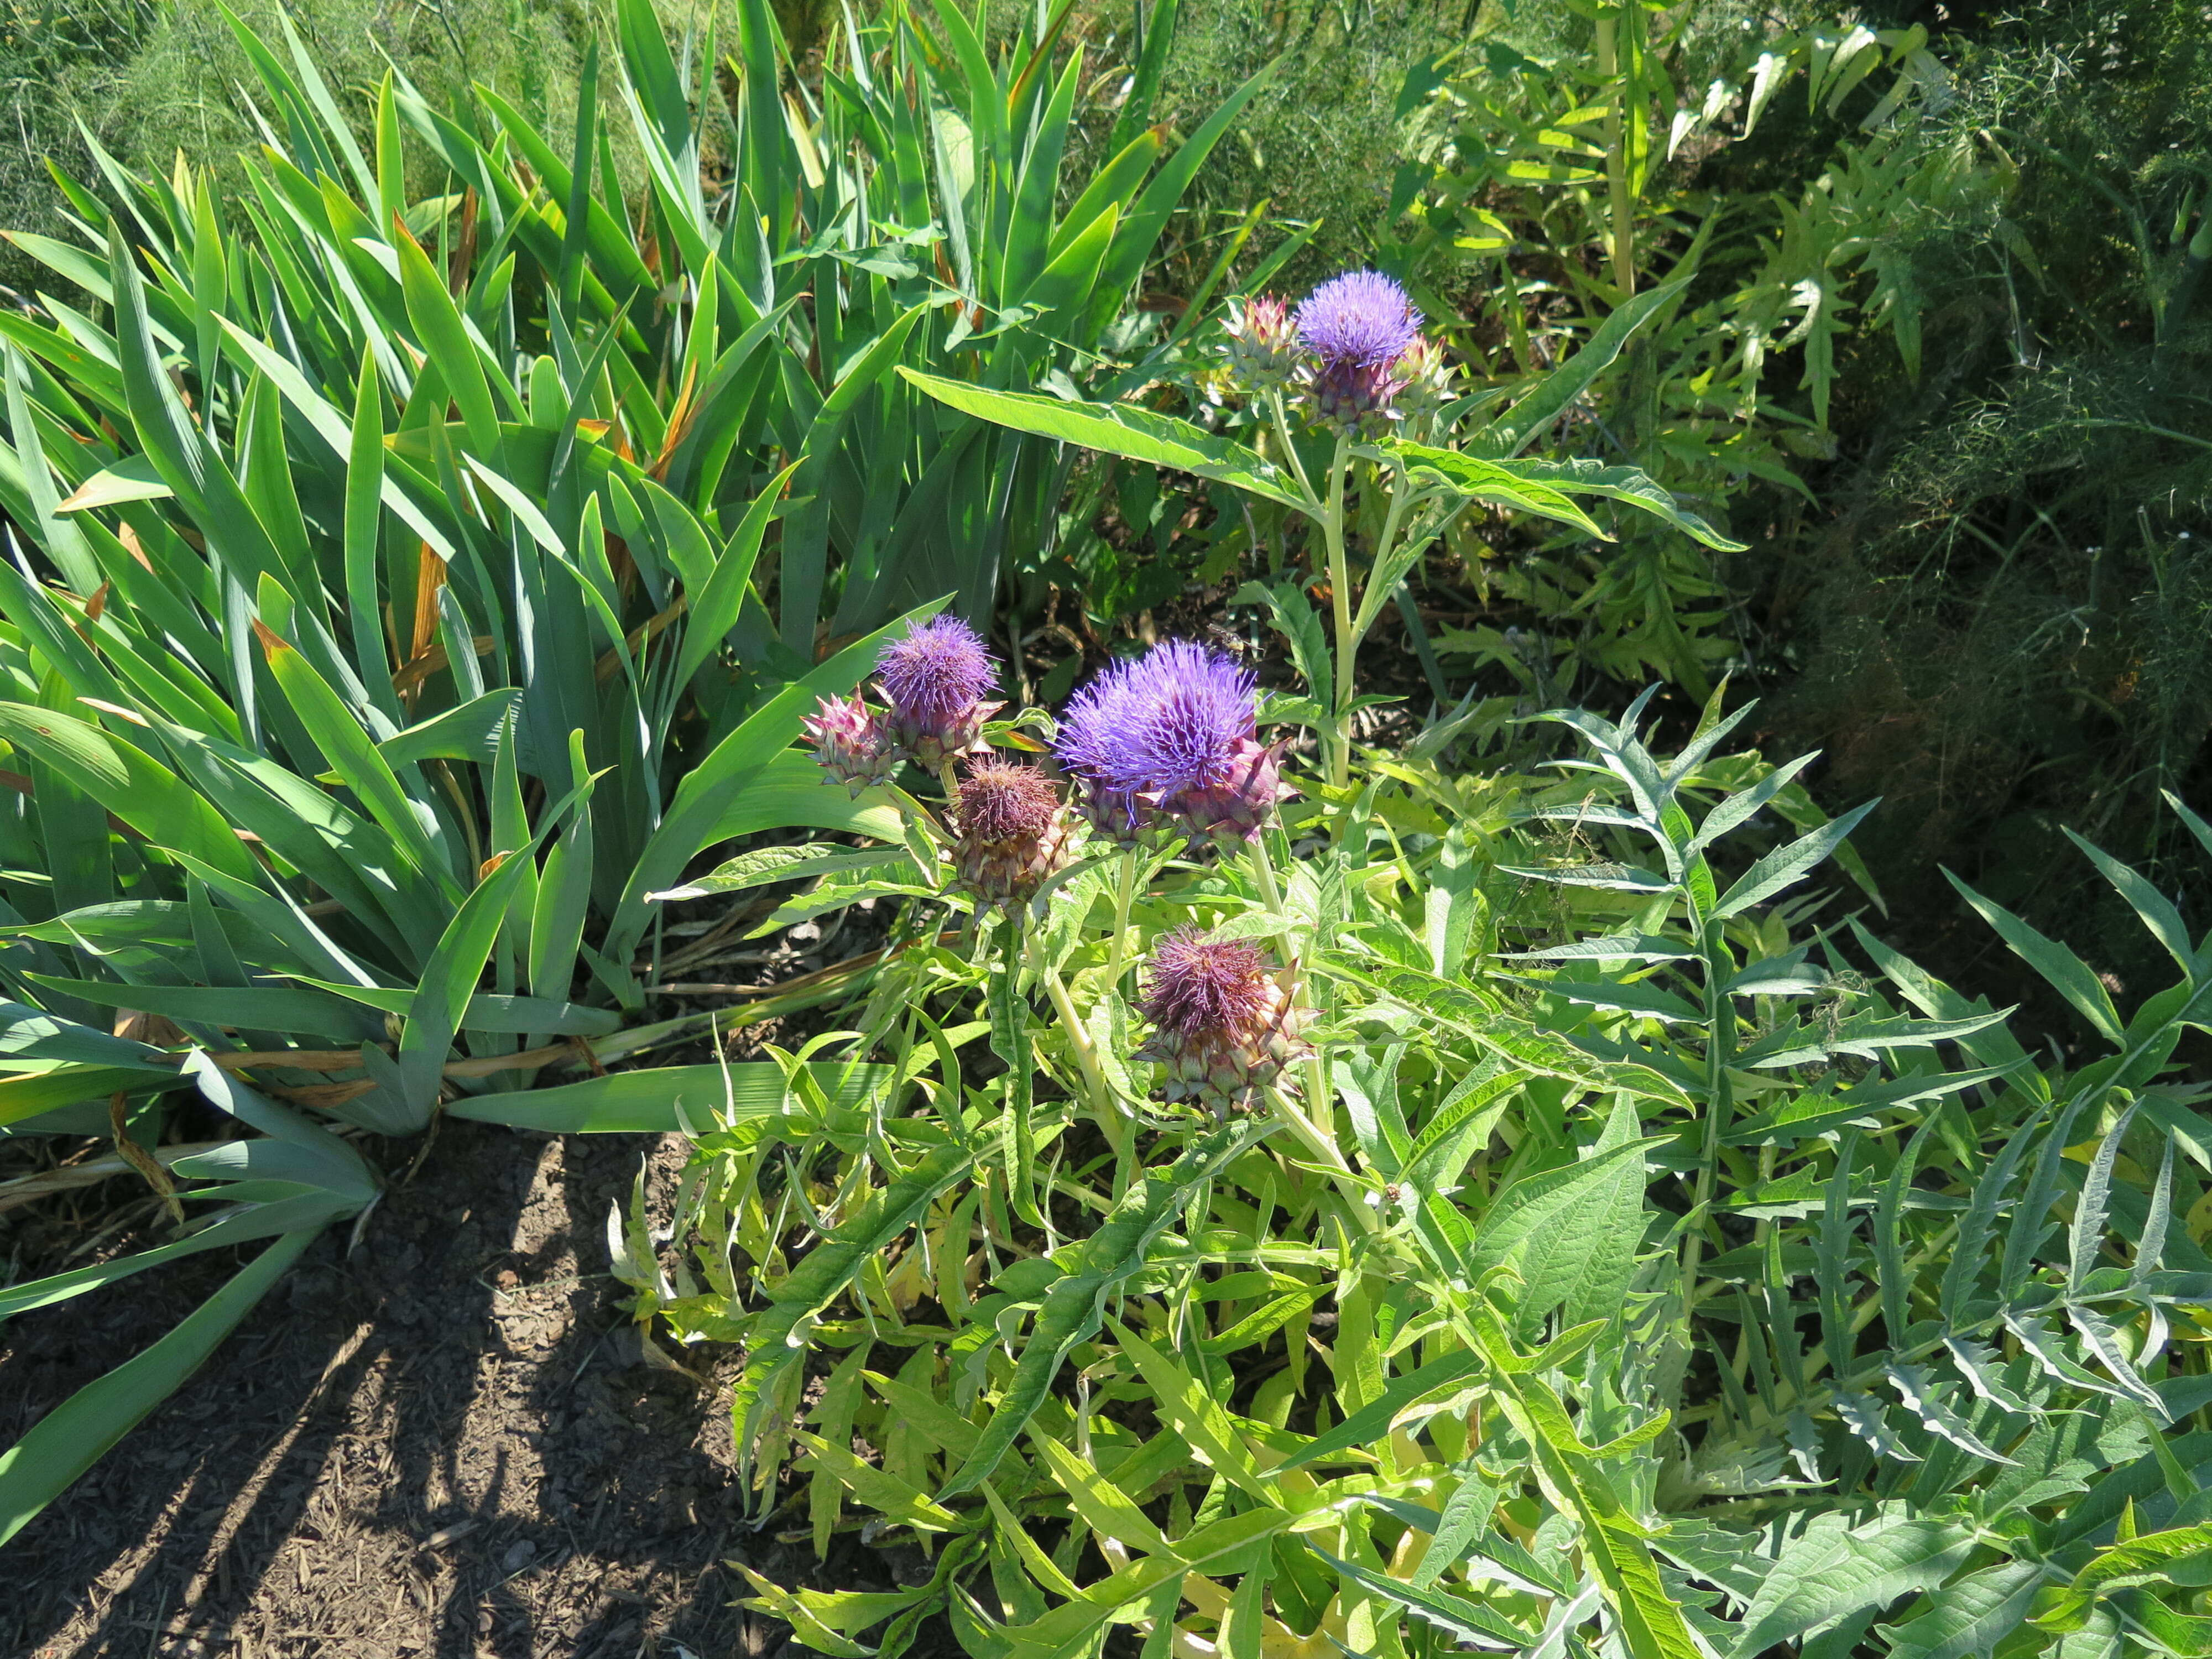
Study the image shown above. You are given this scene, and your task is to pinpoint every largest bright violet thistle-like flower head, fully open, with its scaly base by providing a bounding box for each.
[1057,639,1283,845]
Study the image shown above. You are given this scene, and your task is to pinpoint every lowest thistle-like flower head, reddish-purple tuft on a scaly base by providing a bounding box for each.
[1137,927,1312,1113]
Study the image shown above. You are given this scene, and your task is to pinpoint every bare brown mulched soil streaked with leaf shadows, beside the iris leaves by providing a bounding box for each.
[0,1121,933,1659]
